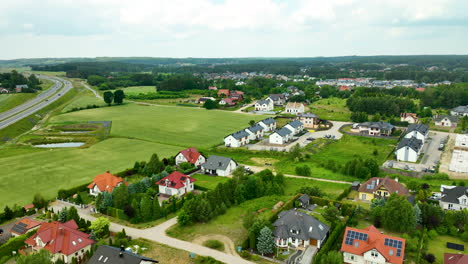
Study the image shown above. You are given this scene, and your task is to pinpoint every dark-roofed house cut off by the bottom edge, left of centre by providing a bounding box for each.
[87,245,159,264]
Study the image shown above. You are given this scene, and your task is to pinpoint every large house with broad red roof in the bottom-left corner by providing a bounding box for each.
[24,220,94,264]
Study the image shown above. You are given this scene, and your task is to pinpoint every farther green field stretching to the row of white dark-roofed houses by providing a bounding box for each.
[51,103,264,148]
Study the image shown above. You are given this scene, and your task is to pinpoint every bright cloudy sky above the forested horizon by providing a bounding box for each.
[0,0,468,59]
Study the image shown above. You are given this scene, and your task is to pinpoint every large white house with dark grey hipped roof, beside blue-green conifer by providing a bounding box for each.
[273,209,330,248]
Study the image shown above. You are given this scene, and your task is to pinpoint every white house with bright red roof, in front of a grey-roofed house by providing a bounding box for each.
[155,171,196,196]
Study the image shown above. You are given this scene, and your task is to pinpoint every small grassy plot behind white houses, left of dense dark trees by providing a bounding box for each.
[309,97,351,121]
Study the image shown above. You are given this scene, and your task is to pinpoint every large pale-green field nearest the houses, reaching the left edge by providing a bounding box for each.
[0,138,181,208]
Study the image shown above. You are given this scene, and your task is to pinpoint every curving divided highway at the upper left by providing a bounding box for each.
[0,75,73,129]
